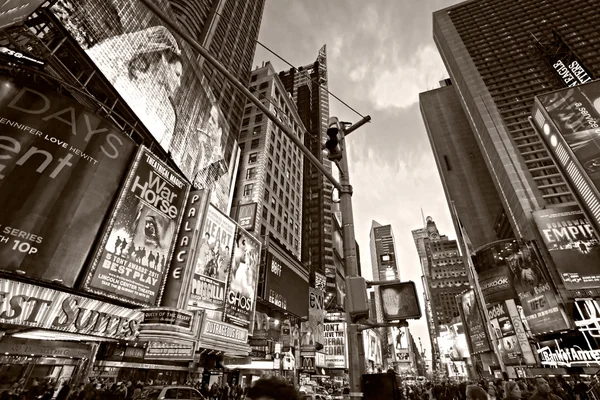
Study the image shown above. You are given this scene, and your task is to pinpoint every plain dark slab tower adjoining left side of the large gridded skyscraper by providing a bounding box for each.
[419,80,514,248]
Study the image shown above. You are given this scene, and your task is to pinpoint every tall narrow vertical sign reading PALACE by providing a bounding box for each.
[162,189,208,308]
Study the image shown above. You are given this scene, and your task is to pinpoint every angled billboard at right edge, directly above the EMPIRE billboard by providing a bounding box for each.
[532,81,600,232]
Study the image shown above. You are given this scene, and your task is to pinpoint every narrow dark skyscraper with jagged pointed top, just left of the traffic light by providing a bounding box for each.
[279,46,335,294]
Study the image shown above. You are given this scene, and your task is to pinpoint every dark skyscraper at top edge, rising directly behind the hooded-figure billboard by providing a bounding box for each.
[169,0,265,152]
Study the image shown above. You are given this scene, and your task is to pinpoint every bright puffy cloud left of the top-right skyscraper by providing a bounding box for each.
[369,44,447,109]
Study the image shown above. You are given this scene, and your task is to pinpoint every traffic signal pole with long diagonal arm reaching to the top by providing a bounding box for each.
[140,0,371,399]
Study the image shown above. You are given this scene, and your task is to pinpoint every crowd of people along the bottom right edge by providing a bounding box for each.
[400,376,591,400]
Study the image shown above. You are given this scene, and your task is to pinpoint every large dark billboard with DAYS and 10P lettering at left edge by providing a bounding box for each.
[0,76,136,287]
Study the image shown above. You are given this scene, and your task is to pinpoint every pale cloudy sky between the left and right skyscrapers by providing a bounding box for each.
[254,0,459,358]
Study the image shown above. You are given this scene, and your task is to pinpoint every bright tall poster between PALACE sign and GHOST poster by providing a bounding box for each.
[189,204,236,319]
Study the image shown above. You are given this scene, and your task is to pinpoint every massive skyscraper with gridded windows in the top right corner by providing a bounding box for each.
[433,0,600,239]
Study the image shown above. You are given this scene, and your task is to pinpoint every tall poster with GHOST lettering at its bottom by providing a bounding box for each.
[224,227,260,330]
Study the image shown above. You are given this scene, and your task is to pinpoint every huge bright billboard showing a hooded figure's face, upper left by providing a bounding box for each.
[51,0,237,212]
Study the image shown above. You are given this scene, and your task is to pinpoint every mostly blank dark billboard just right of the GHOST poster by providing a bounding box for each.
[265,253,309,317]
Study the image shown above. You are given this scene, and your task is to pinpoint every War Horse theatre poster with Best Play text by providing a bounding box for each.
[84,147,189,306]
